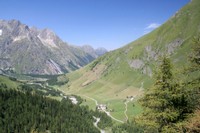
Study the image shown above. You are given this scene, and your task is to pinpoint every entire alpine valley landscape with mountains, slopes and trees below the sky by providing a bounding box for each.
[0,0,200,133]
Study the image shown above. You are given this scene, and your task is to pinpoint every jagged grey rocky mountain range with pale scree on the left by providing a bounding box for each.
[0,20,106,74]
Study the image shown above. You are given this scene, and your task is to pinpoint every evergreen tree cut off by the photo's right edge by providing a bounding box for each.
[183,34,200,133]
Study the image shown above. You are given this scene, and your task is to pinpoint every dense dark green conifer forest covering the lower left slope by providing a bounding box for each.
[0,89,112,133]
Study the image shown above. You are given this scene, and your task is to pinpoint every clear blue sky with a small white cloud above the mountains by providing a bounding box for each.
[0,0,190,50]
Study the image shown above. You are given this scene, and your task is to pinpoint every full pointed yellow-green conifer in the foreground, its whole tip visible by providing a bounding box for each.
[139,57,186,133]
